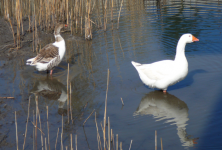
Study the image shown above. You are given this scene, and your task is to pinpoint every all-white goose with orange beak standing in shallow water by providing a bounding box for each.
[132,34,199,93]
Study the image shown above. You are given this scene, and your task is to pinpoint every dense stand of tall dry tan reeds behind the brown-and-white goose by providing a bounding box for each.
[0,0,125,44]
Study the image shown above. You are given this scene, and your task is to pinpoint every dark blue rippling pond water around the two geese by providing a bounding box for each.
[0,0,222,150]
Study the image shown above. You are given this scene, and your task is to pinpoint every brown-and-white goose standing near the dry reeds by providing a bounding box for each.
[26,23,67,75]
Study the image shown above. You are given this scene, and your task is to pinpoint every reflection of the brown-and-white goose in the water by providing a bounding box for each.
[30,78,67,114]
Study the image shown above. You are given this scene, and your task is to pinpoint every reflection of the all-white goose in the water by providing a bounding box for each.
[134,91,196,146]
